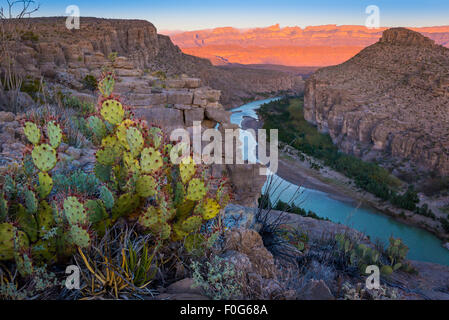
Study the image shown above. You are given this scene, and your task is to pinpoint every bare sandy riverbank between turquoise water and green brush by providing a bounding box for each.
[242,117,449,245]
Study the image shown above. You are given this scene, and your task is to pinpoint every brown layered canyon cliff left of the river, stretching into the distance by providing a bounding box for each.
[1,17,303,107]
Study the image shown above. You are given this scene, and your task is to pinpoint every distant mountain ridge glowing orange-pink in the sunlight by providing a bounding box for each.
[170,24,449,66]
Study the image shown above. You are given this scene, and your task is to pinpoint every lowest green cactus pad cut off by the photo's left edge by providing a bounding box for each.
[0,223,28,261]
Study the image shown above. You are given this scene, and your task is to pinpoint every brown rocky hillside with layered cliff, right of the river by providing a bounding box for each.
[304,28,449,175]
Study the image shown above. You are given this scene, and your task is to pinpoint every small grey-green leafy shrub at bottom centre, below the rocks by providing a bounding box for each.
[190,256,242,300]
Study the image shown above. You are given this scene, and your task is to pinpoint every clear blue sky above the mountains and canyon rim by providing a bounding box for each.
[27,0,449,30]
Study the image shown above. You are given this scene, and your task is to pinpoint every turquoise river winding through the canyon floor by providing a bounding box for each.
[231,98,449,266]
